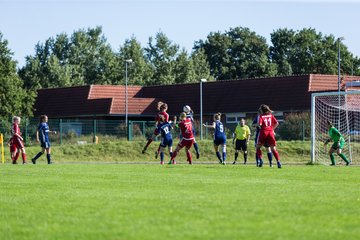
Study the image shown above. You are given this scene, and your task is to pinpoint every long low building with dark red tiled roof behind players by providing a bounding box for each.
[34,74,360,123]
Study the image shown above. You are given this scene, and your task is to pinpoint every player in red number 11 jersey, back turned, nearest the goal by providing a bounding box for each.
[256,104,281,168]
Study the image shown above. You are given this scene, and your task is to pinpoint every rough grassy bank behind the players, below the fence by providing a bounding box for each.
[5,140,316,164]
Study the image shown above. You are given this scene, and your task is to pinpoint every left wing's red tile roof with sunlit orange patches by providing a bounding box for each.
[34,85,159,117]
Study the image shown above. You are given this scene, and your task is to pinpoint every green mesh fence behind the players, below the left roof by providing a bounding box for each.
[0,118,212,145]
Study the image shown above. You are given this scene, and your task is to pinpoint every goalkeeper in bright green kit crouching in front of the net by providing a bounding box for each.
[324,121,350,166]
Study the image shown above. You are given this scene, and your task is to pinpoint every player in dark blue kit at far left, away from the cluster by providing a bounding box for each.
[31,115,56,164]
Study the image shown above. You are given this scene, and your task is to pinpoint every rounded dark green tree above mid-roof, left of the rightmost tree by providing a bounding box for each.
[194,27,276,80]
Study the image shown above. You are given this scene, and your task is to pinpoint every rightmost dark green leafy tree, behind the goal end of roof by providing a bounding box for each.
[270,28,358,75]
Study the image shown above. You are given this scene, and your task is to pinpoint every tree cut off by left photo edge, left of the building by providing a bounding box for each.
[0,32,34,119]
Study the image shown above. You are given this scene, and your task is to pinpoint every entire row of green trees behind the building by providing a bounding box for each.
[0,27,360,117]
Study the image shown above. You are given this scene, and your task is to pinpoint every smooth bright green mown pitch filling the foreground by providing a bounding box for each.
[0,164,360,240]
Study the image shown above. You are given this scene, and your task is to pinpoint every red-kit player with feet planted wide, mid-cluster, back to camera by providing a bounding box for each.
[169,112,195,164]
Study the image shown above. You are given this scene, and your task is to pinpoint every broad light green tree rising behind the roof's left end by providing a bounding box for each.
[19,27,119,89]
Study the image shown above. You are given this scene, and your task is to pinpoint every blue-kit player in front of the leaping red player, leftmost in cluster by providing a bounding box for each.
[158,116,176,164]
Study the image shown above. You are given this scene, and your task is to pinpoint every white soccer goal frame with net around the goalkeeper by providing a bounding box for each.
[311,91,360,164]
